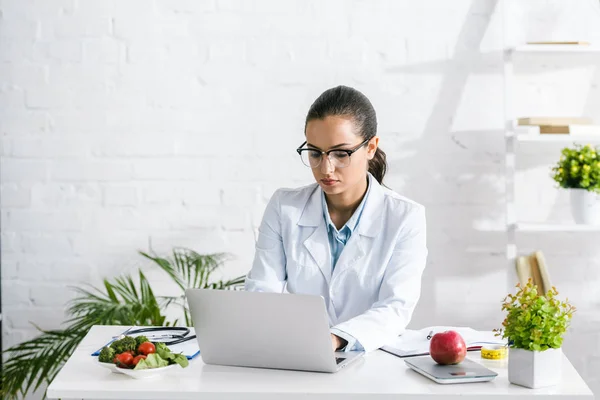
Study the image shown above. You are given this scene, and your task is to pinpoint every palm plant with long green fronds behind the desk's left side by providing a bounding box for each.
[0,248,244,399]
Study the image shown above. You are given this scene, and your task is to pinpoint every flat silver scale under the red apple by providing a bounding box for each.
[404,355,498,384]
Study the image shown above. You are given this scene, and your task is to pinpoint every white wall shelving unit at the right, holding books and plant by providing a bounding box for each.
[504,44,600,288]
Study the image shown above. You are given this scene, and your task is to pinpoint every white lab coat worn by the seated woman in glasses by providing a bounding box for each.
[246,174,427,351]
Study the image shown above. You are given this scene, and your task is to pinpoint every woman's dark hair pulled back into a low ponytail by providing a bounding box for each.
[304,86,387,184]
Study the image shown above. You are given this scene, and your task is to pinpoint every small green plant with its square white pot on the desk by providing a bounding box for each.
[496,279,575,388]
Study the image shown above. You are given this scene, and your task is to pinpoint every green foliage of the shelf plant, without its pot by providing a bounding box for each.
[552,144,600,193]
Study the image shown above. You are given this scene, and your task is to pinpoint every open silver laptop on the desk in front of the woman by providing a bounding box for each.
[185,289,364,372]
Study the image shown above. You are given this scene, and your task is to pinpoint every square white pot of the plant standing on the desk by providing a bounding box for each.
[508,347,562,389]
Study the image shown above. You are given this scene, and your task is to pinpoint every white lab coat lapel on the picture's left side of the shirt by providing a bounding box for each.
[298,186,331,285]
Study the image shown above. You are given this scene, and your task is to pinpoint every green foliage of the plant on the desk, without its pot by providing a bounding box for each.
[495,279,576,351]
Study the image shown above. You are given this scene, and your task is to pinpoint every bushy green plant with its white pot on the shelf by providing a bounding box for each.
[552,145,600,225]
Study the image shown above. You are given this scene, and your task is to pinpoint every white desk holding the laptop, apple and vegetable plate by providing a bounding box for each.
[47,326,593,400]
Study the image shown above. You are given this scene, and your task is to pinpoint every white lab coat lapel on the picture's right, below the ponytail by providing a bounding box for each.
[332,174,384,282]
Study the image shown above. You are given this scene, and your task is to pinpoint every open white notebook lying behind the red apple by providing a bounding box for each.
[381,326,507,357]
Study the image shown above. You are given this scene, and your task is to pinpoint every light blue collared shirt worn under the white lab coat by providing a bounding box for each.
[321,180,371,351]
